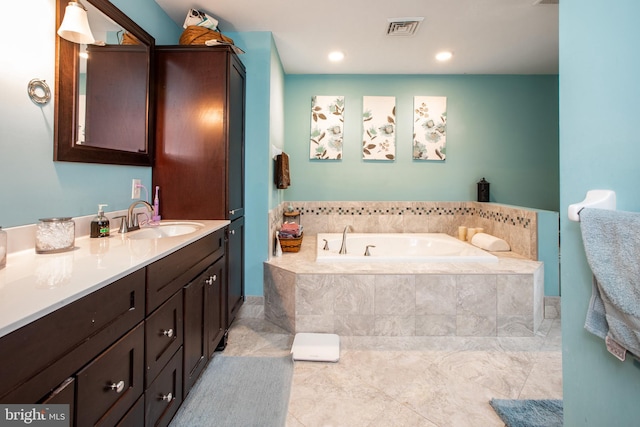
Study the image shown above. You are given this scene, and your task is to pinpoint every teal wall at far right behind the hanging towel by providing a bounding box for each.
[559,0,640,427]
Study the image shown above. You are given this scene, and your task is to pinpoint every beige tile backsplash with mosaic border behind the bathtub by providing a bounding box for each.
[269,202,538,260]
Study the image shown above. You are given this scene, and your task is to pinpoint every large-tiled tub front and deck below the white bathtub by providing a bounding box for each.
[264,234,544,337]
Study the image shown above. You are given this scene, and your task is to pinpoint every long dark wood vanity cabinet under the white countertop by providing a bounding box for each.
[0,228,228,427]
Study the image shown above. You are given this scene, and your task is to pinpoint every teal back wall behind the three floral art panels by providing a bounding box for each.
[285,75,559,211]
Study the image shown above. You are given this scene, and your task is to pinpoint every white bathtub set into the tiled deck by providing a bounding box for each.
[316,233,498,263]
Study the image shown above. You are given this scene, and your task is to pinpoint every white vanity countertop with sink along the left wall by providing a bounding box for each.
[0,220,229,337]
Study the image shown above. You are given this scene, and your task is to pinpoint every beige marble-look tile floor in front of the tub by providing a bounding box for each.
[224,298,562,427]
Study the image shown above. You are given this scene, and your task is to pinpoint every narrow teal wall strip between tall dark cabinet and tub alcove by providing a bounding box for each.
[226,32,284,295]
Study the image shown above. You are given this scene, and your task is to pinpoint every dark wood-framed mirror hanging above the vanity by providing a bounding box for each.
[54,0,155,166]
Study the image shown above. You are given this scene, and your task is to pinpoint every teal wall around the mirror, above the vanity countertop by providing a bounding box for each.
[0,0,180,227]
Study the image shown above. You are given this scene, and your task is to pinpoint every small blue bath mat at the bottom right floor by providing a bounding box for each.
[489,399,562,427]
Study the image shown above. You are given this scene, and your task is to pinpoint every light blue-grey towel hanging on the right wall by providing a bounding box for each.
[580,208,640,357]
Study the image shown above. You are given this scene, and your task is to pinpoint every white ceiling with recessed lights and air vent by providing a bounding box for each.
[156,0,558,74]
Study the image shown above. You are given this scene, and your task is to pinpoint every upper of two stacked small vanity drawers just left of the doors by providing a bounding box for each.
[145,292,183,386]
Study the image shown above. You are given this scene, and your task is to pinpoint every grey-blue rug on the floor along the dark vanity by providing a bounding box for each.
[169,355,293,427]
